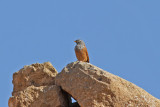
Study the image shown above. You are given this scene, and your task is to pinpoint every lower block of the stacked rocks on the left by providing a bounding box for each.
[8,85,68,107]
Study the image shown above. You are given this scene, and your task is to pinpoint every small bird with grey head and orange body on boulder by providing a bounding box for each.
[74,39,89,63]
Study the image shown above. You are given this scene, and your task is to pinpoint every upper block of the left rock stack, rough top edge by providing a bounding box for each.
[12,62,58,95]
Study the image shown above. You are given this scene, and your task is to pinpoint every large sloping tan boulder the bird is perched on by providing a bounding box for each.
[56,61,160,107]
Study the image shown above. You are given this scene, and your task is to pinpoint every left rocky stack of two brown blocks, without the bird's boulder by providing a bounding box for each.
[8,62,68,107]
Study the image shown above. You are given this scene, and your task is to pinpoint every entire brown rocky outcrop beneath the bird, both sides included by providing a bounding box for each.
[8,61,160,107]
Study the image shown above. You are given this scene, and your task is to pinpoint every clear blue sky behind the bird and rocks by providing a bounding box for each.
[0,0,160,107]
